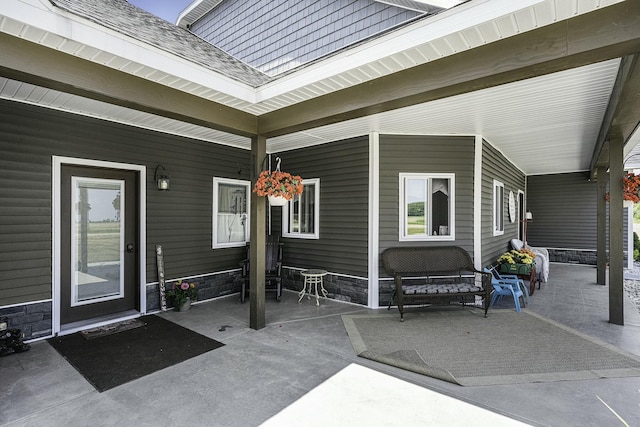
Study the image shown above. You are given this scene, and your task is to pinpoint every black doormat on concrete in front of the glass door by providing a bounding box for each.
[47,316,224,392]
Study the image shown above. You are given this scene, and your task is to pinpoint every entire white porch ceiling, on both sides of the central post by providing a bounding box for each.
[0,59,624,175]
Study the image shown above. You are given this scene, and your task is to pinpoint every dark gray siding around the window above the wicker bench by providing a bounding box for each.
[380,135,475,260]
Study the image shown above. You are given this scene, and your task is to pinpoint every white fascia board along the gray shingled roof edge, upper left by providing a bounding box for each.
[0,0,256,103]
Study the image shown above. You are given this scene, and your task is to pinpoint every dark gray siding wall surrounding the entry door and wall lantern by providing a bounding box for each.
[0,101,250,342]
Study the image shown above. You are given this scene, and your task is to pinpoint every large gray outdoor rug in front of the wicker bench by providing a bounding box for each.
[342,309,640,386]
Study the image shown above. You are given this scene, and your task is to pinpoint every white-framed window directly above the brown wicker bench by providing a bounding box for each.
[400,173,455,241]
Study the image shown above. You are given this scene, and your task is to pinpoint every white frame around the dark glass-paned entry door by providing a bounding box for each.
[51,156,147,335]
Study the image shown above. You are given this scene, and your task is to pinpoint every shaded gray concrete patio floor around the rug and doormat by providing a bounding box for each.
[0,264,640,427]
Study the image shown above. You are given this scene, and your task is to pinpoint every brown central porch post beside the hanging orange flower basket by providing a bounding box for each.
[249,135,267,329]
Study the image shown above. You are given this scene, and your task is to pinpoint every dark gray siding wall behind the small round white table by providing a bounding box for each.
[271,136,369,304]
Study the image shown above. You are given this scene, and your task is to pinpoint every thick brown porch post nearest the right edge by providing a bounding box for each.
[609,136,624,325]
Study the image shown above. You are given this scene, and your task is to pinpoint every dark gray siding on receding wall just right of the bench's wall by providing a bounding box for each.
[481,140,531,266]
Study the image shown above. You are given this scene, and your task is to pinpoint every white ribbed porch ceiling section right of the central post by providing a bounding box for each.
[268,59,620,175]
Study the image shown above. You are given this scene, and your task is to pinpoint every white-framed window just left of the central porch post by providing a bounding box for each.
[212,178,251,248]
